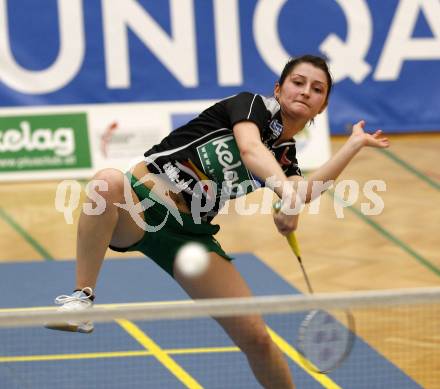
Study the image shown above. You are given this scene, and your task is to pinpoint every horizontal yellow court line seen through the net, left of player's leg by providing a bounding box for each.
[0,346,240,363]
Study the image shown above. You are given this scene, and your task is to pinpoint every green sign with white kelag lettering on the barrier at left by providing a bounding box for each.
[0,114,91,172]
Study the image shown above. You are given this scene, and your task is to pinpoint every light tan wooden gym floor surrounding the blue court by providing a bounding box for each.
[0,133,440,387]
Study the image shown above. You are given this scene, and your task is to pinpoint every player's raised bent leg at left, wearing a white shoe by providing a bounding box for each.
[46,169,144,333]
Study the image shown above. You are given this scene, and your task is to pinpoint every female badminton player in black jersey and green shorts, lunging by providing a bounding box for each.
[48,55,388,388]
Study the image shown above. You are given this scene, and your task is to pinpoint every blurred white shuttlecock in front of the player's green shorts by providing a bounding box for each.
[176,242,209,277]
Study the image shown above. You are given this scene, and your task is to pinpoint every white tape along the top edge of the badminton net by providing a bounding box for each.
[0,287,440,327]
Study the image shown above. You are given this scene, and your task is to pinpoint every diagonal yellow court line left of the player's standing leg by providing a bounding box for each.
[116,319,203,389]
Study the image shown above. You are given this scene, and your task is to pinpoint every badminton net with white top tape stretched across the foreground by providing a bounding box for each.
[0,288,440,389]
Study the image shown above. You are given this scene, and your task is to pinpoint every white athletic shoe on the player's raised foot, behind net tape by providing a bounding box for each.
[45,287,93,334]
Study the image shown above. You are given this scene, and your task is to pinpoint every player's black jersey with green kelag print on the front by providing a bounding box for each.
[144,92,301,221]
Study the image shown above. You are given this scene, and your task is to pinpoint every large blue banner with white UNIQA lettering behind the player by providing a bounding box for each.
[0,0,440,132]
